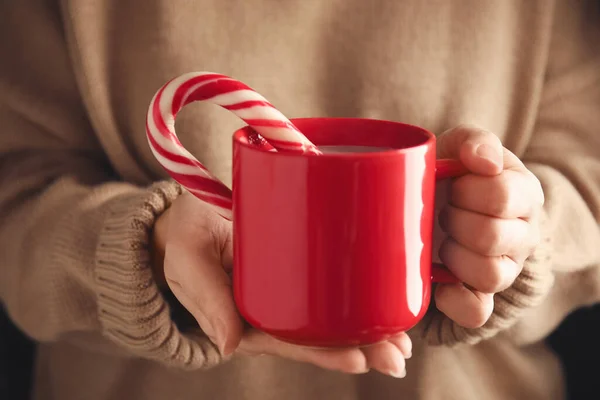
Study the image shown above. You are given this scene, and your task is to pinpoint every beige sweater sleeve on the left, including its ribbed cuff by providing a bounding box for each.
[0,1,220,369]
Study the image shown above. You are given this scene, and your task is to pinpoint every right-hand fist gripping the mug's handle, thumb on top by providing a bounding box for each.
[435,126,544,328]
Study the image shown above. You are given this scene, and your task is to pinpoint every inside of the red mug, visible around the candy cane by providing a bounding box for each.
[233,118,435,157]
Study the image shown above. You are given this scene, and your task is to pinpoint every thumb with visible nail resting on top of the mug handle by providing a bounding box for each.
[437,125,504,176]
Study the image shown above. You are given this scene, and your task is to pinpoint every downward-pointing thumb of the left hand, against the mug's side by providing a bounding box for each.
[165,220,243,355]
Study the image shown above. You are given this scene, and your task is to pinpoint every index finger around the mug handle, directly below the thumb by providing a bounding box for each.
[449,170,544,219]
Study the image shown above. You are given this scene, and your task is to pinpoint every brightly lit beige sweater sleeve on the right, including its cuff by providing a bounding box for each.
[423,1,600,345]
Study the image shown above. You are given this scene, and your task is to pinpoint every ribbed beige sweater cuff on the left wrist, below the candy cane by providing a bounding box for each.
[95,182,220,369]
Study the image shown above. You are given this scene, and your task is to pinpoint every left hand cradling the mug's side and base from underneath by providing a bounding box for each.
[153,192,412,377]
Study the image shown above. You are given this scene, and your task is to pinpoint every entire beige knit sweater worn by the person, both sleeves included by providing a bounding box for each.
[0,0,600,400]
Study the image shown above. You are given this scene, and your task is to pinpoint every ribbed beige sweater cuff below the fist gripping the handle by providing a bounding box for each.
[420,214,554,346]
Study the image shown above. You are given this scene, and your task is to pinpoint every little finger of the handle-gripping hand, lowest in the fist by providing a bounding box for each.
[435,283,494,329]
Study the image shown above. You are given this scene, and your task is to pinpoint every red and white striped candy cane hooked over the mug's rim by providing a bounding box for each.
[146,72,320,220]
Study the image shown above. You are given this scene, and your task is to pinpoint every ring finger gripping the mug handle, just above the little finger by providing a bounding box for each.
[439,238,522,293]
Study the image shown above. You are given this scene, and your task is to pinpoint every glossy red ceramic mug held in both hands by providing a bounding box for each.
[233,118,466,347]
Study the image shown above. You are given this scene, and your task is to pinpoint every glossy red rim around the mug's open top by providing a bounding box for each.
[233,117,436,159]
